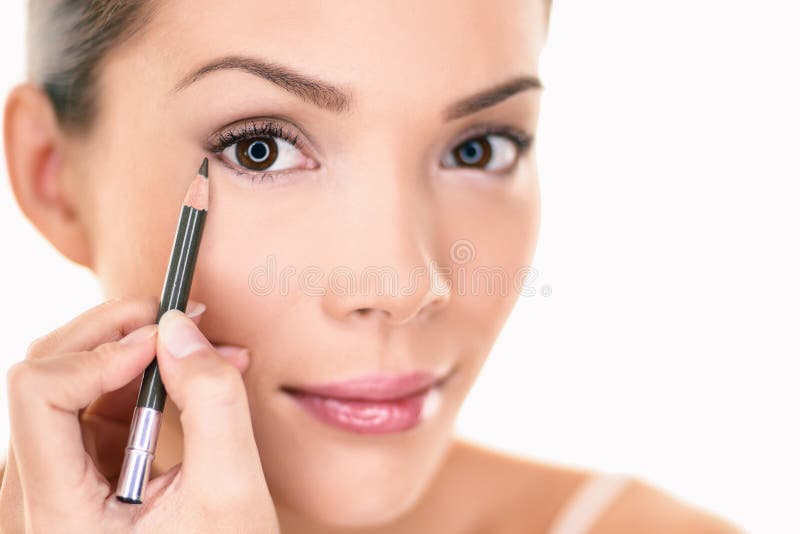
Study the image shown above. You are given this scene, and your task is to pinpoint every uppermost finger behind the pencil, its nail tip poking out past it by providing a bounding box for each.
[26,296,205,359]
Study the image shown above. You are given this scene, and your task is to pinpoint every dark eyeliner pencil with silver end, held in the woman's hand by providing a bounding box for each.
[117,158,208,504]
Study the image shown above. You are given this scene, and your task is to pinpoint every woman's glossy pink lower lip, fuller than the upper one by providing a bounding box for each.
[290,388,440,434]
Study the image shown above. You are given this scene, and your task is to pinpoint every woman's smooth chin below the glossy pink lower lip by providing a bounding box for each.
[256,396,452,528]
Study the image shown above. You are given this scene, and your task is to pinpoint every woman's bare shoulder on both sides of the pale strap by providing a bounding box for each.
[448,441,744,534]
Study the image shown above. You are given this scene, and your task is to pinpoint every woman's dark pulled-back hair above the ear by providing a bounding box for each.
[27,0,151,131]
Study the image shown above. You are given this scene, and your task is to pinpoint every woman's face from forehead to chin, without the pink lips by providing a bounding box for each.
[66,0,544,525]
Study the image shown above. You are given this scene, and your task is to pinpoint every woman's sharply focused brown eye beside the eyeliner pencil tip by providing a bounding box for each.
[222,136,308,171]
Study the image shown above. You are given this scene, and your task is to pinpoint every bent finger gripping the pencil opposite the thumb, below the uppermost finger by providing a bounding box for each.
[6,323,159,517]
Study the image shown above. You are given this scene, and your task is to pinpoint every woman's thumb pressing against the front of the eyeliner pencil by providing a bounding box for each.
[156,310,266,503]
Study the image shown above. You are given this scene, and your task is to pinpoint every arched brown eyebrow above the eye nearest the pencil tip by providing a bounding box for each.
[174,56,353,113]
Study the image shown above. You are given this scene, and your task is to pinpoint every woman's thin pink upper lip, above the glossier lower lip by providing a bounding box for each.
[281,372,449,400]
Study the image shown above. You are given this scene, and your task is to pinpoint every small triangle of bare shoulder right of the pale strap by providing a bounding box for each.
[590,477,744,534]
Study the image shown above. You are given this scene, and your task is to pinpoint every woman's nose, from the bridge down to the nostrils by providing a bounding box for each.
[322,170,451,326]
